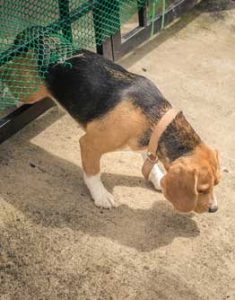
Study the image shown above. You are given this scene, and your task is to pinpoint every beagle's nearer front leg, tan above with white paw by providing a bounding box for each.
[80,135,116,208]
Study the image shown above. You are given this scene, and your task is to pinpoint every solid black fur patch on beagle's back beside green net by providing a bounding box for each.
[46,50,138,124]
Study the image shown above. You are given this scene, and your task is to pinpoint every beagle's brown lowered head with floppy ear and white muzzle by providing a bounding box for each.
[161,144,220,213]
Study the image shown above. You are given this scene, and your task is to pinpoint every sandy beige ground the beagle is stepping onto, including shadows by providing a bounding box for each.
[0,2,235,300]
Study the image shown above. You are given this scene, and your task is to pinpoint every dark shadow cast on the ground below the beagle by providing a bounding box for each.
[0,108,199,251]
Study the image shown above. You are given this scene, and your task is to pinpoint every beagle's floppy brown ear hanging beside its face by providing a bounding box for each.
[161,164,198,212]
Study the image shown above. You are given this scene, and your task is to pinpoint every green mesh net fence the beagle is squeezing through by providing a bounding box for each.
[0,0,176,111]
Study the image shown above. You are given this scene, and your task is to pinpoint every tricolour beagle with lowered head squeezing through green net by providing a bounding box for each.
[0,28,220,213]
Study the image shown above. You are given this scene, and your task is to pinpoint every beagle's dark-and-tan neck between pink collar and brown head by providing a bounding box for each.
[157,113,201,166]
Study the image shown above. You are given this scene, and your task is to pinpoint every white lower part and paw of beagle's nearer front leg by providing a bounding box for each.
[84,174,117,208]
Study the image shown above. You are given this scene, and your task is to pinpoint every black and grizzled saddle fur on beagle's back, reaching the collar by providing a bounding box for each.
[46,50,171,124]
